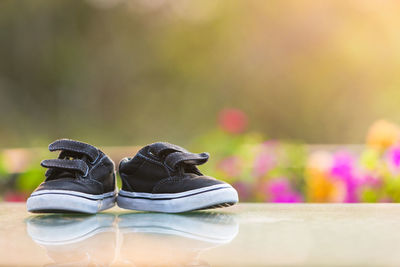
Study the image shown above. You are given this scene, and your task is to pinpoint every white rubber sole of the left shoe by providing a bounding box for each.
[26,190,117,214]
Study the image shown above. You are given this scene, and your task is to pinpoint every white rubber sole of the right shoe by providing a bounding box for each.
[117,184,239,213]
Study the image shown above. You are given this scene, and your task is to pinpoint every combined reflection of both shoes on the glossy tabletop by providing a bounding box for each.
[27,211,239,266]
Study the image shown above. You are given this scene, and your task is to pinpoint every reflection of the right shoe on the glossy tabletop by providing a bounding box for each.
[118,212,238,266]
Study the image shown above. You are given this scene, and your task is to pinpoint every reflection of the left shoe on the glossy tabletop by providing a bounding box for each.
[27,214,117,266]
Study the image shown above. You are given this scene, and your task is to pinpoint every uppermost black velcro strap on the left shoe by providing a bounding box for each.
[49,139,99,161]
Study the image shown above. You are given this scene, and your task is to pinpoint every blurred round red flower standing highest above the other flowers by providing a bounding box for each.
[219,109,247,134]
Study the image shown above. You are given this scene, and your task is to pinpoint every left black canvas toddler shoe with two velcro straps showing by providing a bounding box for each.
[26,139,117,213]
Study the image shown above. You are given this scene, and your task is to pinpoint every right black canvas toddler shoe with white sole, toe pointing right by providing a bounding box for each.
[117,142,238,212]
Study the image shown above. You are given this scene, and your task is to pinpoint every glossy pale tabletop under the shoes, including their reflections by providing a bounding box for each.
[0,203,400,266]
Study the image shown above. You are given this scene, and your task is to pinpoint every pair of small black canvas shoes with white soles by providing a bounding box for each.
[27,139,238,213]
